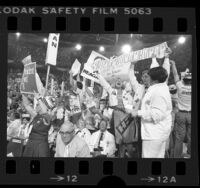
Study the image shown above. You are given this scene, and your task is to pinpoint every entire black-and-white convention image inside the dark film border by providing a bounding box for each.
[7,32,192,159]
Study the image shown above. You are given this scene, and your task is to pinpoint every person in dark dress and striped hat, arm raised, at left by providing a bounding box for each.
[22,94,55,157]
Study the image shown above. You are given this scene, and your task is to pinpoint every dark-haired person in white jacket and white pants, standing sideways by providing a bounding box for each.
[132,67,172,158]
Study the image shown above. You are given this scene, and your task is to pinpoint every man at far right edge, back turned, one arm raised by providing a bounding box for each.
[170,60,192,158]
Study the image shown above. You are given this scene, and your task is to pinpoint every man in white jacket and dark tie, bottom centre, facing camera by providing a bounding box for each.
[90,120,116,157]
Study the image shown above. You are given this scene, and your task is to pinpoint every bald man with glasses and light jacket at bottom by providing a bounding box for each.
[55,121,91,157]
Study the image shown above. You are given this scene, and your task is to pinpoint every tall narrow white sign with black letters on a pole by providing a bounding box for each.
[45,33,60,66]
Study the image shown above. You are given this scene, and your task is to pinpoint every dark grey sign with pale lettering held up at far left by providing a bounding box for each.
[20,62,39,94]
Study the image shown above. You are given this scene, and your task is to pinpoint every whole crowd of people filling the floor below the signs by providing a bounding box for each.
[7,49,191,158]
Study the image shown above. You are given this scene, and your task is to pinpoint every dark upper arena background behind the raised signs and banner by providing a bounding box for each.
[8,33,192,83]
